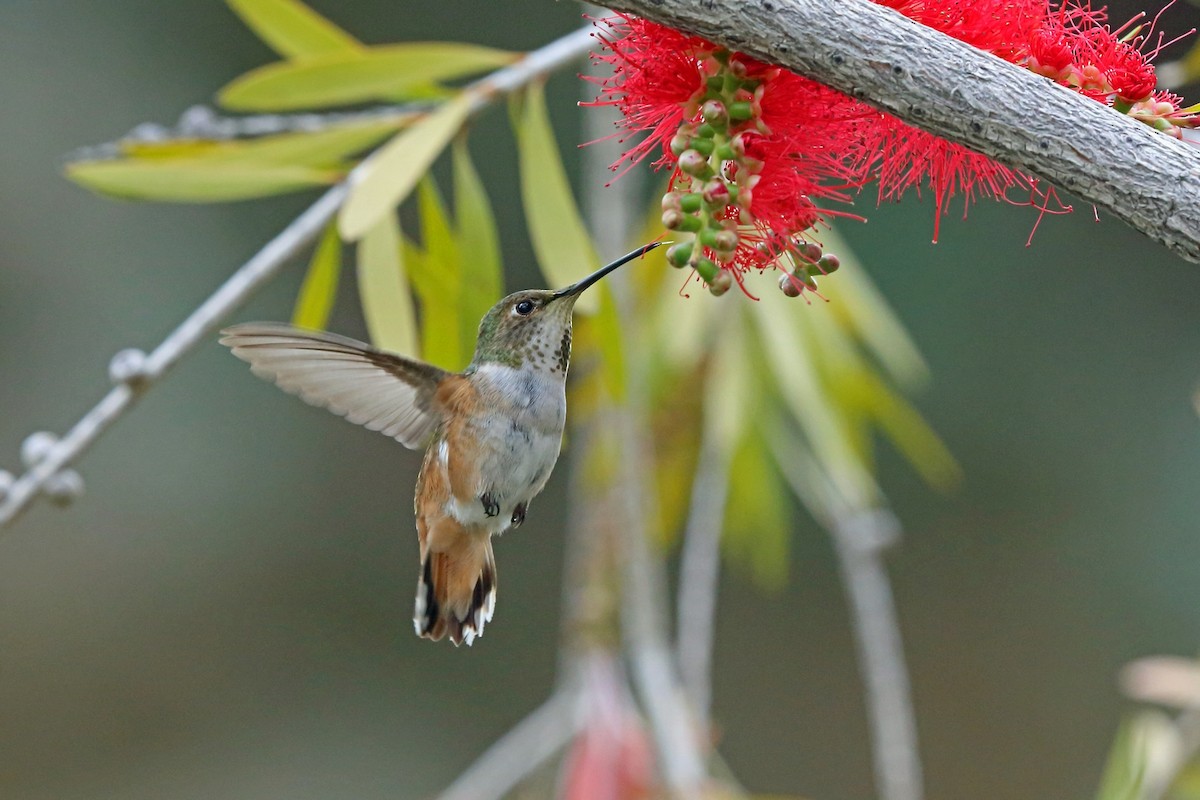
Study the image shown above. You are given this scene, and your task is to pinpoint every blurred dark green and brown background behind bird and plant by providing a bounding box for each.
[0,0,1200,800]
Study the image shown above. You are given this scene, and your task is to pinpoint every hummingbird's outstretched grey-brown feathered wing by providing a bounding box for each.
[221,323,451,449]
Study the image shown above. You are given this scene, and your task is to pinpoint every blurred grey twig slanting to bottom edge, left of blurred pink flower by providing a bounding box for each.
[440,688,583,800]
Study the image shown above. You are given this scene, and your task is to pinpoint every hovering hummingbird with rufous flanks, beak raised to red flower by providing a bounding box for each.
[221,242,662,645]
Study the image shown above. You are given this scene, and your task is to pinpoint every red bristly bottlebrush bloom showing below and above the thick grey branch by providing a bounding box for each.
[594,0,1200,294]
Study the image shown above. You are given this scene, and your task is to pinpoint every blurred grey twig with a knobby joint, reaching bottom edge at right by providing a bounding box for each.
[769,435,924,800]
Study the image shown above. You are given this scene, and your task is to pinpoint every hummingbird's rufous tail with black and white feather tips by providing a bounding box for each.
[413,535,496,645]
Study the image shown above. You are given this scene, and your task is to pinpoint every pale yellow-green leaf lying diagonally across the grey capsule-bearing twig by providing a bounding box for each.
[337,95,470,241]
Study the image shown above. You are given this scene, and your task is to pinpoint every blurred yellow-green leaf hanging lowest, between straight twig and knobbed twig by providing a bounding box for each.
[721,435,788,589]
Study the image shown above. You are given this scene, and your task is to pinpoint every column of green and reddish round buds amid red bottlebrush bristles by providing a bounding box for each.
[662,49,767,295]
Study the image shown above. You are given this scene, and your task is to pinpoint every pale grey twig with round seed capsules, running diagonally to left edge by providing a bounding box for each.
[0,25,594,528]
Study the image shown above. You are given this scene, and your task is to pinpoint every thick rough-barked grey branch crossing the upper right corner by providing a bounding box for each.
[610,0,1200,261]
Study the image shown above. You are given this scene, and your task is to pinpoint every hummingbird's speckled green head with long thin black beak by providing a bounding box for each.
[472,242,662,374]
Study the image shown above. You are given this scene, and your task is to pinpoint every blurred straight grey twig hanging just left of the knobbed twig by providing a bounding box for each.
[676,431,730,730]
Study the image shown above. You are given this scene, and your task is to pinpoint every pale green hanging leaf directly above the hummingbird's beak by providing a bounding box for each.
[516,83,600,313]
